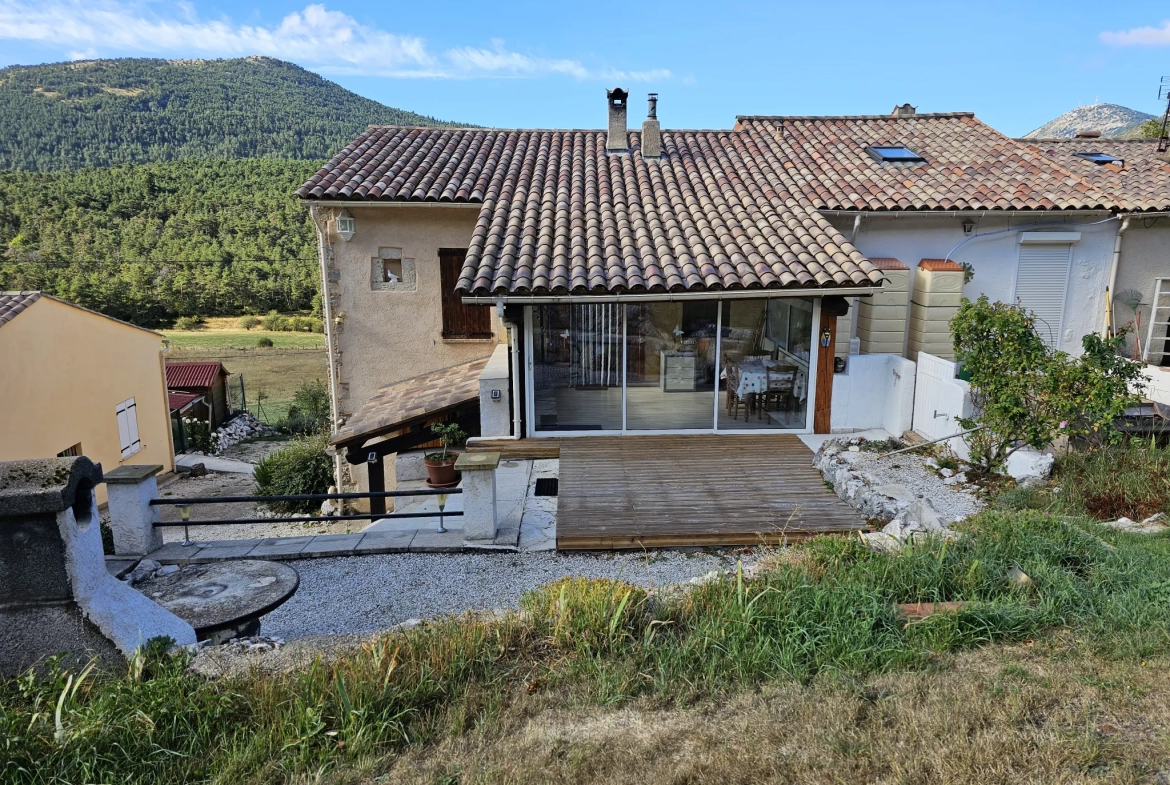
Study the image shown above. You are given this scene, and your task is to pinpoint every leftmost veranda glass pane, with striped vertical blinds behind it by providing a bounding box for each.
[532,303,622,432]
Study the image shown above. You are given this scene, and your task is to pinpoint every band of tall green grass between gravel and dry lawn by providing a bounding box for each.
[0,511,1170,784]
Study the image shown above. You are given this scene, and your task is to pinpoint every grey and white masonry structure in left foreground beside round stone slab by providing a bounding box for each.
[0,457,195,675]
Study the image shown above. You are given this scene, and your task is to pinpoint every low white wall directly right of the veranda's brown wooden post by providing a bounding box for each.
[830,354,914,436]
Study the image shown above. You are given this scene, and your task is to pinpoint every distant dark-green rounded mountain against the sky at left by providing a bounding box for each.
[0,57,463,172]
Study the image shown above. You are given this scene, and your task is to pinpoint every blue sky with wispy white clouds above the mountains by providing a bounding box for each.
[0,0,1170,135]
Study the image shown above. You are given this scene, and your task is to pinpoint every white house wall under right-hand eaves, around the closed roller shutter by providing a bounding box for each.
[831,212,1128,353]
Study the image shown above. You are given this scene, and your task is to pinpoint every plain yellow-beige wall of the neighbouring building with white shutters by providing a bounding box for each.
[0,297,174,503]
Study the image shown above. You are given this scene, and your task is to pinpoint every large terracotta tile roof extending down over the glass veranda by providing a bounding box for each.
[297,128,882,296]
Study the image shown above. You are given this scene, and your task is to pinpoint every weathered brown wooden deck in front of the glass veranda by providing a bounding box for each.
[557,434,866,550]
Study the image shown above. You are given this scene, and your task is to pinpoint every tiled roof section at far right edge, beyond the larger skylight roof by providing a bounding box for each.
[1020,139,1170,211]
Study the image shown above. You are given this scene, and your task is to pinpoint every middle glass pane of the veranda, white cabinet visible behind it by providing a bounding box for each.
[626,299,718,431]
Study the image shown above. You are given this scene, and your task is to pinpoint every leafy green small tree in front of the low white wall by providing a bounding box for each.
[950,296,1141,471]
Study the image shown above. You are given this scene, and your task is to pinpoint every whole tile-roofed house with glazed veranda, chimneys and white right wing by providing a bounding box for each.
[297,90,1160,493]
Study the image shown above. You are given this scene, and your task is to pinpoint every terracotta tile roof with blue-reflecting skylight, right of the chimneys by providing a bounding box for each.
[739,112,1115,211]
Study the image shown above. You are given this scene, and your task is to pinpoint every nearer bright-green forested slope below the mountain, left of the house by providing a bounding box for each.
[0,160,319,326]
